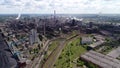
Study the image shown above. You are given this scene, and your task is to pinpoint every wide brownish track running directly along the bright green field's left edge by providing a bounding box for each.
[42,35,79,68]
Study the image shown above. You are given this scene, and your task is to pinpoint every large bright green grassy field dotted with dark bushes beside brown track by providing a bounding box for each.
[54,38,86,68]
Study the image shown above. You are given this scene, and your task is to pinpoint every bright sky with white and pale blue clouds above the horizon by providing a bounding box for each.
[0,0,120,14]
